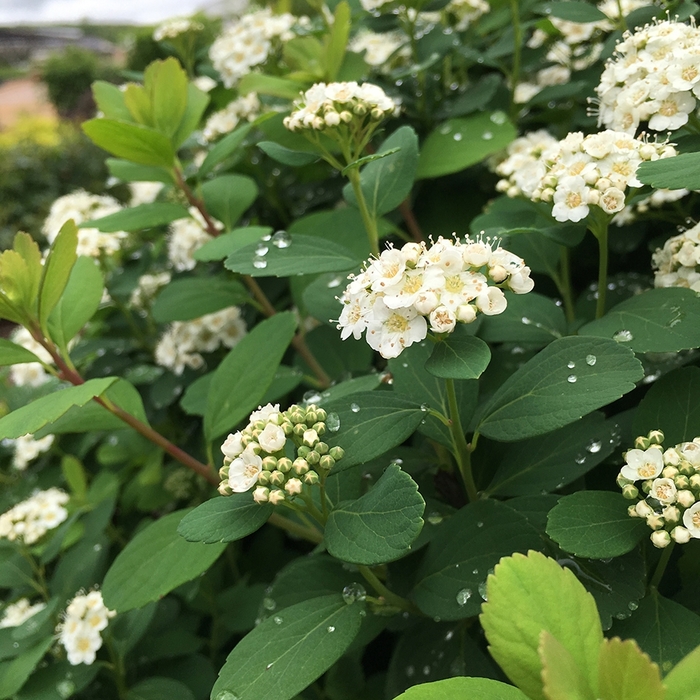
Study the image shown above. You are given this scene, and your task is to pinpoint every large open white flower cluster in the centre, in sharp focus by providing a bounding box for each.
[338,237,534,358]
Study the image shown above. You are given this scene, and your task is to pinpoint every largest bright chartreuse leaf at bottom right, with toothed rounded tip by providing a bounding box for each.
[480,552,603,700]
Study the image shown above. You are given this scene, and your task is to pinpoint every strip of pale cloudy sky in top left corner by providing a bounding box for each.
[0,0,209,25]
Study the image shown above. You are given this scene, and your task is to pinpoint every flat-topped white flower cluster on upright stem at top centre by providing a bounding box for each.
[284,81,399,131]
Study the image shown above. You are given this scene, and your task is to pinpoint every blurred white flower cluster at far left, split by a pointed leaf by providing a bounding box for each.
[42,190,129,258]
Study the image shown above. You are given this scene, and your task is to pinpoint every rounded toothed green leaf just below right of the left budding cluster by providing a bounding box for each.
[324,464,425,566]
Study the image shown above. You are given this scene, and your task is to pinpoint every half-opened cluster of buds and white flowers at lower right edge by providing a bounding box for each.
[617,430,700,549]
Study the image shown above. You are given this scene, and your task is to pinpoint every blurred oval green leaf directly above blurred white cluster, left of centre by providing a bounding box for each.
[151,277,248,323]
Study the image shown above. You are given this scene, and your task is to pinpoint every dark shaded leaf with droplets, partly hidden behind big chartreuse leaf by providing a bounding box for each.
[411,500,543,620]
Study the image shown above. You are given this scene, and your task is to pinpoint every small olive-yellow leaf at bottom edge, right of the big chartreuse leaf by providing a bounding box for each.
[598,637,664,700]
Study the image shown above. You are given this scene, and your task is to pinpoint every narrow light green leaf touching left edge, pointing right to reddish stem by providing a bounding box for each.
[0,377,117,440]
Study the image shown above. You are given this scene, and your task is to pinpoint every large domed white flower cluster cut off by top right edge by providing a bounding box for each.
[596,20,700,134]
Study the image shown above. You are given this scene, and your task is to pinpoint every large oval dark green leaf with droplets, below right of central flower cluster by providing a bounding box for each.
[477,336,644,442]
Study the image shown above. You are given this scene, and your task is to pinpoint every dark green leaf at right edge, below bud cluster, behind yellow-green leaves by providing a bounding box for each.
[613,588,700,672]
